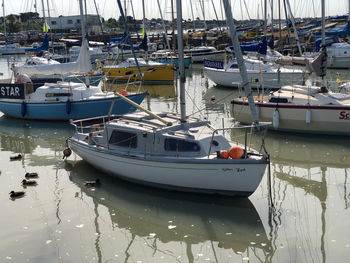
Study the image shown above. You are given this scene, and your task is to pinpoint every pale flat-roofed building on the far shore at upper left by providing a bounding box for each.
[46,15,101,34]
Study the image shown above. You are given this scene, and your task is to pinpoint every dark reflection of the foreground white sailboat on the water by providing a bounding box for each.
[70,161,271,262]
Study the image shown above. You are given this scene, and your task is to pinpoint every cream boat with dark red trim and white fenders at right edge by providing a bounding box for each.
[232,85,350,135]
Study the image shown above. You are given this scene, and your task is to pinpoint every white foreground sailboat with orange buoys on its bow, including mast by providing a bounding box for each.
[67,0,269,197]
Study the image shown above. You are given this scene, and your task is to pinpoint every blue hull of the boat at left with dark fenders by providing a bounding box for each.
[0,93,146,120]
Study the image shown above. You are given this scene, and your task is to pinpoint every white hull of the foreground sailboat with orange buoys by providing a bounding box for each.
[68,137,268,197]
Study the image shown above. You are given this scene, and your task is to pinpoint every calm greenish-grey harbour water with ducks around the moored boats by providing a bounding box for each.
[0,56,350,262]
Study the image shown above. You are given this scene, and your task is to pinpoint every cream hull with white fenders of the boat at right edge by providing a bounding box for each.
[232,99,350,135]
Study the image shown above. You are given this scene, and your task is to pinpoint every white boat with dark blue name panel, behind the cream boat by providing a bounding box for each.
[204,59,305,89]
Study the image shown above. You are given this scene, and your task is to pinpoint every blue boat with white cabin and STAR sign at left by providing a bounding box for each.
[0,82,147,121]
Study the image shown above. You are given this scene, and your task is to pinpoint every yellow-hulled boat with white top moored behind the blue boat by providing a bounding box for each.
[102,58,175,84]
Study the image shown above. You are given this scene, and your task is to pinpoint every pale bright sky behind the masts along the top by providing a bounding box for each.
[3,0,350,20]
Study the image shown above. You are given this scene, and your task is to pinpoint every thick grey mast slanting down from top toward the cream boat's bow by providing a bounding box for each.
[223,0,259,124]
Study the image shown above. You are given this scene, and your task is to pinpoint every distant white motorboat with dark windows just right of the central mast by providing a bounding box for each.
[184,46,225,63]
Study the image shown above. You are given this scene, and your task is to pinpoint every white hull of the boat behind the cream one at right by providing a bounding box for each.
[204,67,304,88]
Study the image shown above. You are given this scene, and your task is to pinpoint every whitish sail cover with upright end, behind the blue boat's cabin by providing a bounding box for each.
[14,39,91,76]
